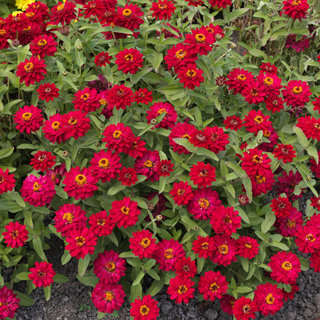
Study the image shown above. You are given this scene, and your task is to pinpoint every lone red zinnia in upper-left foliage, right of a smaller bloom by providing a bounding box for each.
[115,48,143,74]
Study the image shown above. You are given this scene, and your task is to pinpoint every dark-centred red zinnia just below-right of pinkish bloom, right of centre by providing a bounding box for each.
[210,206,241,236]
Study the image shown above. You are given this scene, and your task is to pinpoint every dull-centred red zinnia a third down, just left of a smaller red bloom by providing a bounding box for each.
[106,84,133,110]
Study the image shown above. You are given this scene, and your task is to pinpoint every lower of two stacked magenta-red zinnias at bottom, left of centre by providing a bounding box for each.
[91,280,126,314]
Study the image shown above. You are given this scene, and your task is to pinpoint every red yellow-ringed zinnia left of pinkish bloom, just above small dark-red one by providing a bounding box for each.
[90,150,121,183]
